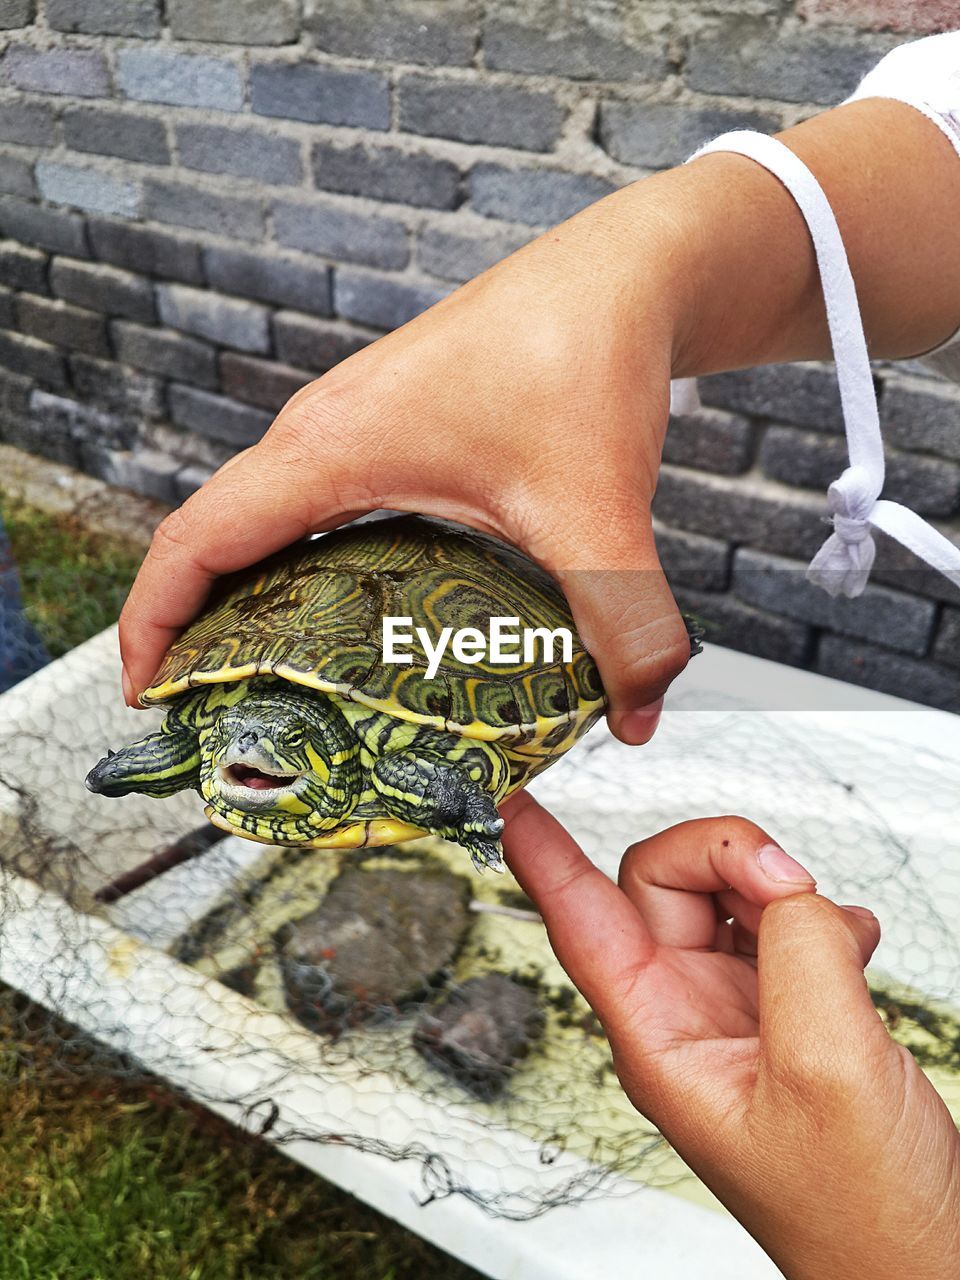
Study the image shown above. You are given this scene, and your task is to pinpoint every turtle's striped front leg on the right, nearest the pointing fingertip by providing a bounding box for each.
[370,750,512,870]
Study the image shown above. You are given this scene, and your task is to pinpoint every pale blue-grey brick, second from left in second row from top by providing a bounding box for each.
[116,49,243,111]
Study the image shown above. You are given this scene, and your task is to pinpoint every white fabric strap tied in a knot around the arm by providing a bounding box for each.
[671,129,960,596]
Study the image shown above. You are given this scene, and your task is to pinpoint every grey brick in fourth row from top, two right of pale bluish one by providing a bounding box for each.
[274,201,410,269]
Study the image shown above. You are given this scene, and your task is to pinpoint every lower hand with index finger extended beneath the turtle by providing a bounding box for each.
[503,794,960,1280]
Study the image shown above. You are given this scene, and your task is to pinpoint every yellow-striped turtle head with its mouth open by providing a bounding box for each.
[200,681,361,845]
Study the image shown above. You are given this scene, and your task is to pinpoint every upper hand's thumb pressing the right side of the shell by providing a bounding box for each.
[554,507,690,745]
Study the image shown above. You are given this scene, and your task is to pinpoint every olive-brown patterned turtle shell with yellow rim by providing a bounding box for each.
[141,516,604,750]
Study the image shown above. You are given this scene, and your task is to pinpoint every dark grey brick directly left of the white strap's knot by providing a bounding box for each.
[653,463,828,559]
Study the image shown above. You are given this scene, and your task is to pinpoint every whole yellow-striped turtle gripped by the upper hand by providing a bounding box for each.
[86,515,607,869]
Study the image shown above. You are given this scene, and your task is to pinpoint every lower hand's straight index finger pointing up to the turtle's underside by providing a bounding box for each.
[500,791,654,1029]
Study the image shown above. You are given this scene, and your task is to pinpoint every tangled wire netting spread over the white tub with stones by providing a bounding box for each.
[0,634,960,1219]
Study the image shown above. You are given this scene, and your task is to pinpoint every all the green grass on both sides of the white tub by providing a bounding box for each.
[0,493,477,1280]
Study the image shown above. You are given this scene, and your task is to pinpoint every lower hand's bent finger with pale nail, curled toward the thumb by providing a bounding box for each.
[620,817,815,950]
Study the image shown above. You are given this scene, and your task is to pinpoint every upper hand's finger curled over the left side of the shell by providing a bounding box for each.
[120,445,367,698]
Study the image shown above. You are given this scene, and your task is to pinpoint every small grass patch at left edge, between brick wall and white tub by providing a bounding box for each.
[0,492,142,658]
